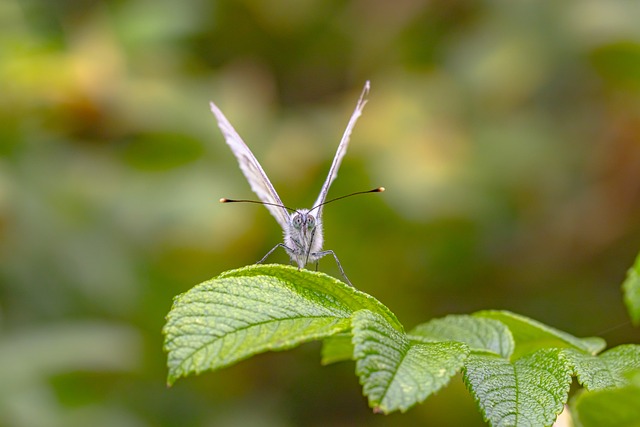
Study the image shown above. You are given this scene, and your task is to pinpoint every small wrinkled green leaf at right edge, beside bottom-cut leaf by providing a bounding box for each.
[565,344,640,390]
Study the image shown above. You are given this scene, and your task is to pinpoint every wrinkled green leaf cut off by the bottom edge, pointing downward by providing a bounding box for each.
[463,349,571,426]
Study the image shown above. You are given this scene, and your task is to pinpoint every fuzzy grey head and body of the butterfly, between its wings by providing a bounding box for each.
[284,209,323,268]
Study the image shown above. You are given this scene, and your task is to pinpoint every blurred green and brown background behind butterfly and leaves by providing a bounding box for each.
[0,0,640,427]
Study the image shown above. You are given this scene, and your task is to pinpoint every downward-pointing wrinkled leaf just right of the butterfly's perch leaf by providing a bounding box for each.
[352,310,469,413]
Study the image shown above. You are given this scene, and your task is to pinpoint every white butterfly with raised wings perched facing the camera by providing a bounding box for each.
[211,81,384,284]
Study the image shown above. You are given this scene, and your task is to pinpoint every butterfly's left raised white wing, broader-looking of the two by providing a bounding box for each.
[211,102,289,230]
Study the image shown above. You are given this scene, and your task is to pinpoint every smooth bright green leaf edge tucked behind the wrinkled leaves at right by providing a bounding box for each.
[473,310,606,359]
